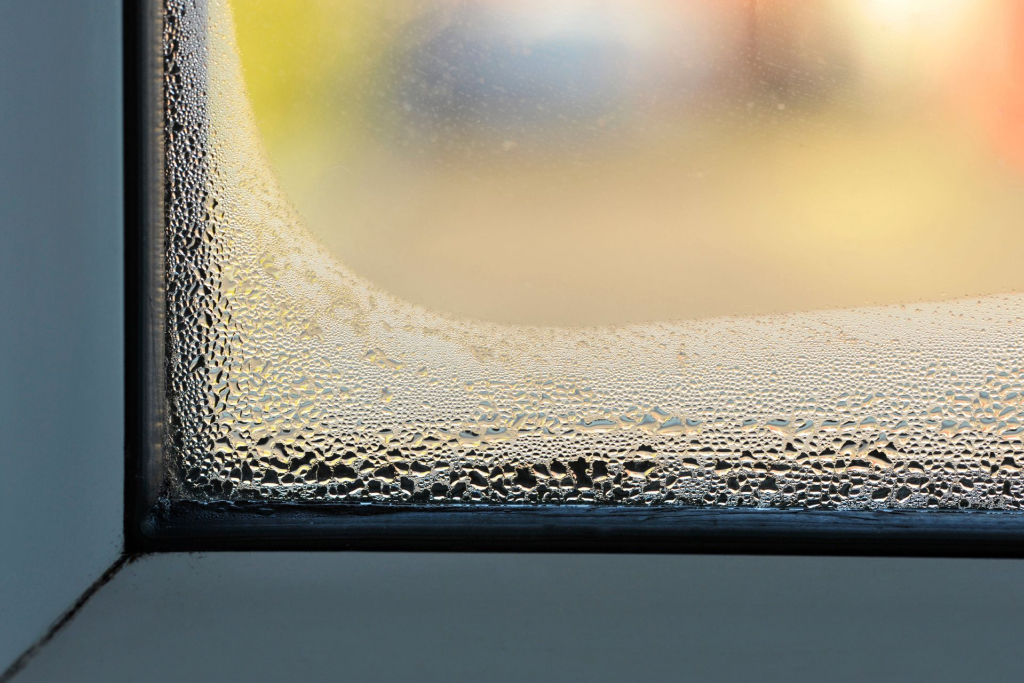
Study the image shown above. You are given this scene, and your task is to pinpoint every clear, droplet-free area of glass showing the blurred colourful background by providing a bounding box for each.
[232,0,1024,325]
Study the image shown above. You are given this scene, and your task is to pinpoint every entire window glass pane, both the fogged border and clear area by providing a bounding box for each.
[164,0,1024,509]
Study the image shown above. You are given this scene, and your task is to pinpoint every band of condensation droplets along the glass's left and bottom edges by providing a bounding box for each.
[164,0,1024,509]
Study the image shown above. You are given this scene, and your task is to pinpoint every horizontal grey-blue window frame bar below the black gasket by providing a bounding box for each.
[17,553,1024,683]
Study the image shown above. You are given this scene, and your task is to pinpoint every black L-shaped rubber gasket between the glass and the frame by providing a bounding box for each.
[124,0,1024,557]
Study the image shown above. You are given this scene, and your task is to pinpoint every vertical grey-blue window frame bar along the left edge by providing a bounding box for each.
[0,0,124,671]
